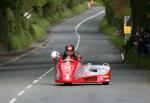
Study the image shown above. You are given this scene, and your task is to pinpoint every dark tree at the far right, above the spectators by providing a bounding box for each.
[128,0,150,47]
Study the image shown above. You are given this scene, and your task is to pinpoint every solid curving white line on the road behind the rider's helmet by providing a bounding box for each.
[75,10,105,51]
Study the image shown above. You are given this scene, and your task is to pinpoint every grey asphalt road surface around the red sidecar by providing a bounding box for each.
[0,7,150,103]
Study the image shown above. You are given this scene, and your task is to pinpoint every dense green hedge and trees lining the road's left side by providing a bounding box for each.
[0,0,85,51]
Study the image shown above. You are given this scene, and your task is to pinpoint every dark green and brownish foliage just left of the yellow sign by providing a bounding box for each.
[102,0,131,35]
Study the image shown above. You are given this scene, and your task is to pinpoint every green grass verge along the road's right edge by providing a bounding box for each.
[99,18,150,69]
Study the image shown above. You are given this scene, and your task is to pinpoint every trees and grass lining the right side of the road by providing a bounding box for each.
[100,0,150,69]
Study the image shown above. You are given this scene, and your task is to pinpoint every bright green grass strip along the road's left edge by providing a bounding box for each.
[7,2,87,52]
